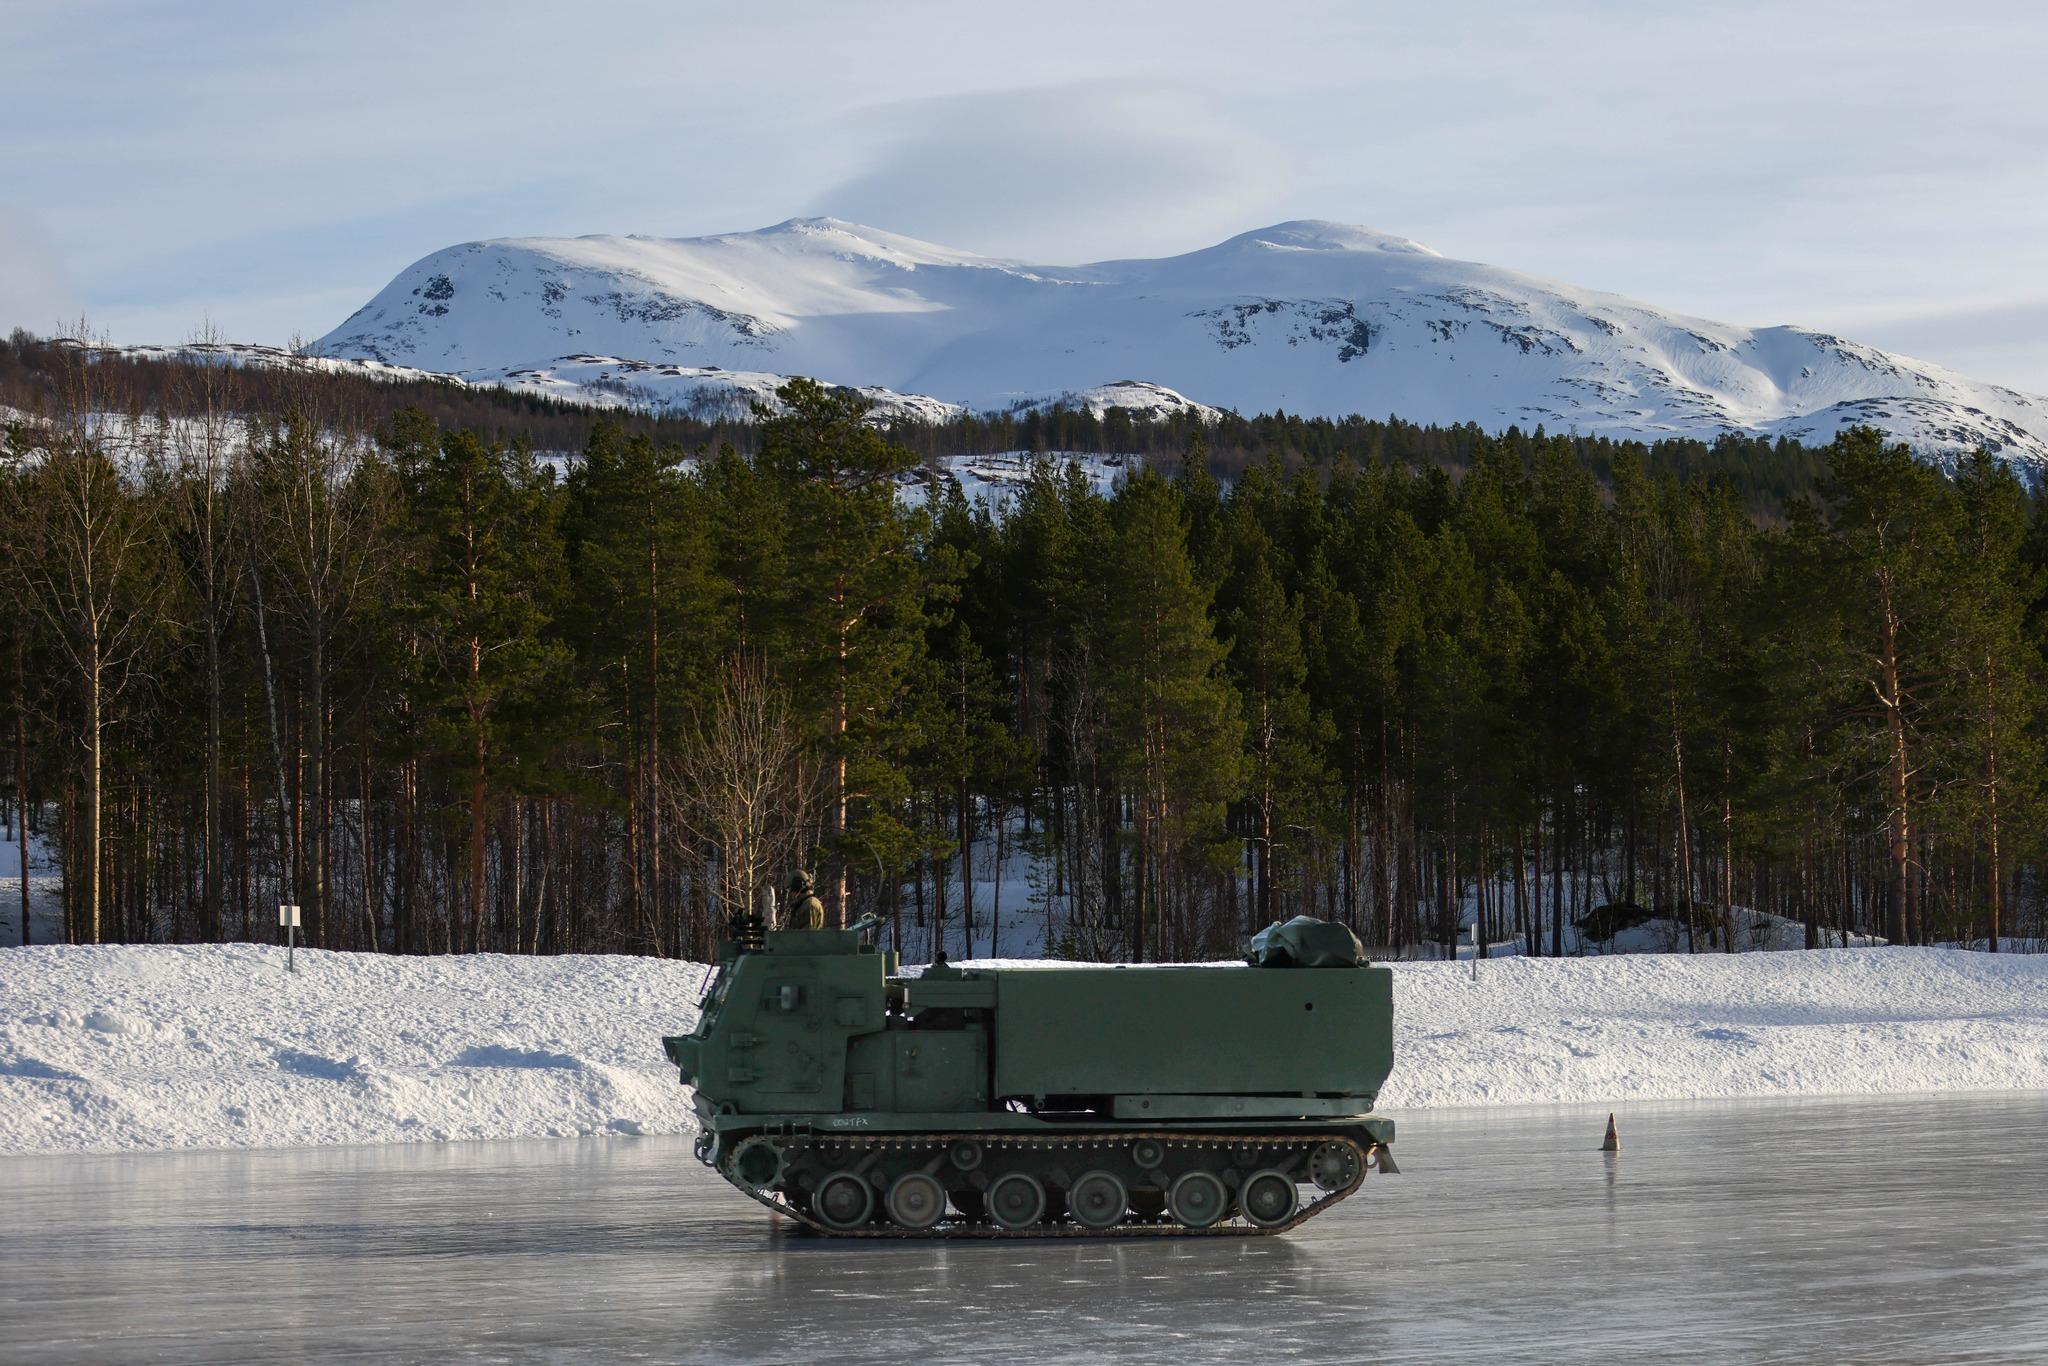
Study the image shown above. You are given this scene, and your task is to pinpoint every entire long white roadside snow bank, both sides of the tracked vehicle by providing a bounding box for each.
[0,944,2048,1153]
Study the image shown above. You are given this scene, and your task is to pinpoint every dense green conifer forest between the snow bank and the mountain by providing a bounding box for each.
[0,334,2048,961]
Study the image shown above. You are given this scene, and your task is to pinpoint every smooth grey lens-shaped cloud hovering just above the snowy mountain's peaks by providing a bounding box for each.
[813,82,1294,262]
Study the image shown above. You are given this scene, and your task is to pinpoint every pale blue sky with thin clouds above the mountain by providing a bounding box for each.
[0,0,2048,393]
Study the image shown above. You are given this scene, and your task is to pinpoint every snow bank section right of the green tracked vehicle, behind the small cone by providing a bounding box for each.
[1380,948,2048,1110]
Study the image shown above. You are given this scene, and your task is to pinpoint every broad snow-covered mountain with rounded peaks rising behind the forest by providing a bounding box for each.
[315,219,2048,463]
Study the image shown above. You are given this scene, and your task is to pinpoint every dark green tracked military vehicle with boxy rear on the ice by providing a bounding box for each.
[662,920,1395,1237]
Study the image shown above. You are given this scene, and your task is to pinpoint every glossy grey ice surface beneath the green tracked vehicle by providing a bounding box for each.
[0,1094,2048,1366]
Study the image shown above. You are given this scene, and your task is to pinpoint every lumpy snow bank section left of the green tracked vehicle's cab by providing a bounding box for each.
[0,944,707,1153]
